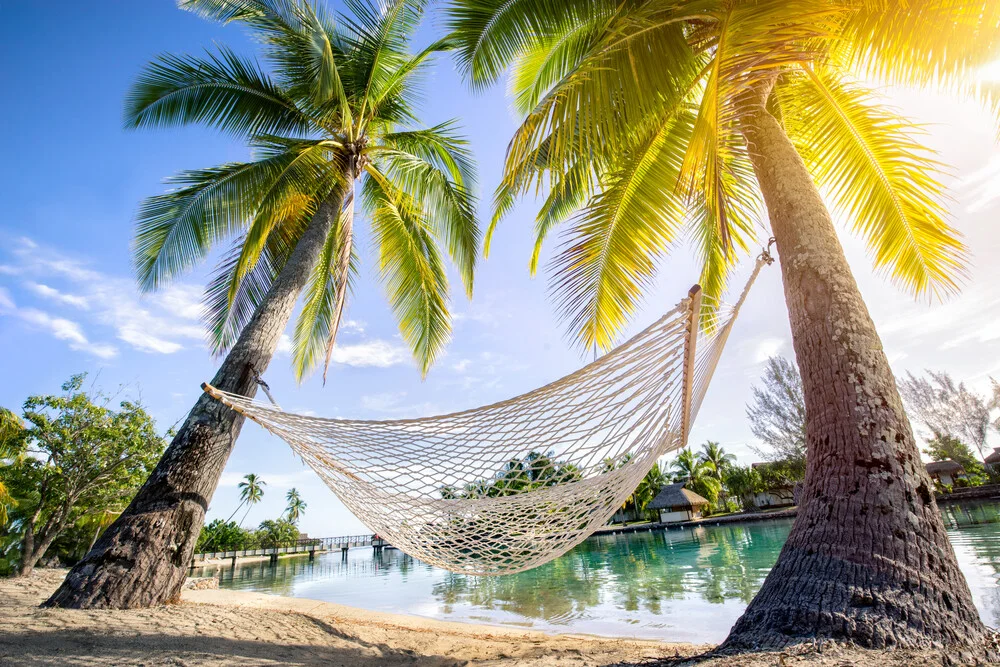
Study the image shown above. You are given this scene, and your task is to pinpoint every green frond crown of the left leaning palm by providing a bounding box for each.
[133,0,480,380]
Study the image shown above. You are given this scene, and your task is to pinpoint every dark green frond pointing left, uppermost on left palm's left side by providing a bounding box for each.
[125,48,315,137]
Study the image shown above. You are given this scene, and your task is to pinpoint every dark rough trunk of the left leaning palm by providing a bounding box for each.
[45,171,353,609]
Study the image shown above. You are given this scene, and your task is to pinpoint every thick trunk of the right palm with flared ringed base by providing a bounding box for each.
[722,89,985,651]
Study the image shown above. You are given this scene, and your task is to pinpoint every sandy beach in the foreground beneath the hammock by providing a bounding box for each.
[0,570,992,667]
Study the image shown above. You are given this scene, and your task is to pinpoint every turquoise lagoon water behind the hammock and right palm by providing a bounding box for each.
[193,503,1000,642]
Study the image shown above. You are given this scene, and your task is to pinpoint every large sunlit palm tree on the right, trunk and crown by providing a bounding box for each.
[448,0,1000,649]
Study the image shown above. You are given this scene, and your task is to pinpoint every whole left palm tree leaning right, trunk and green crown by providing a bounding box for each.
[47,0,480,607]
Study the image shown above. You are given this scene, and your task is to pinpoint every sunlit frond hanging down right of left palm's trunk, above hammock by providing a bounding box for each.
[362,165,451,375]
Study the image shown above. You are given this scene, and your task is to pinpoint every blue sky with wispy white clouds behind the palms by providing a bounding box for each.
[0,0,1000,535]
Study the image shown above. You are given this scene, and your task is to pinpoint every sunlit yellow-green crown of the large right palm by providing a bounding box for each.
[449,0,1000,349]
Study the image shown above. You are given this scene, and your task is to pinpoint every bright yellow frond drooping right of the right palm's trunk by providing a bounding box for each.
[779,70,967,295]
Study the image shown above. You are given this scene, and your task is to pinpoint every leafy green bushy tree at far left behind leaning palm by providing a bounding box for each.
[0,373,166,574]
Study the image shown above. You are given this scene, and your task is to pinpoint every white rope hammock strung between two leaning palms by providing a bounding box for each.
[203,250,772,575]
